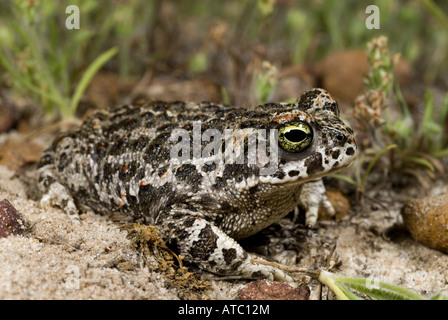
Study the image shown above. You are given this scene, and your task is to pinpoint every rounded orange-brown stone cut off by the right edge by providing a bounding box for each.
[401,194,448,253]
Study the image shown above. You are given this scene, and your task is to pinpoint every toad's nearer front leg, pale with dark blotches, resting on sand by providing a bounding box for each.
[159,212,293,282]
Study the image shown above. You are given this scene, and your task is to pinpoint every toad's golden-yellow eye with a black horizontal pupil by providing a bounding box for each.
[278,121,313,152]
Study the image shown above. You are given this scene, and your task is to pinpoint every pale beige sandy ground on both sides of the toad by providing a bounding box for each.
[0,154,448,300]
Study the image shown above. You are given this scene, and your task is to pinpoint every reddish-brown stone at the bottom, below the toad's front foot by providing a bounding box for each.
[238,280,310,300]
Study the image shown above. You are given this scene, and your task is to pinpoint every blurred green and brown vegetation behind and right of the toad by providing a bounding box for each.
[0,0,448,196]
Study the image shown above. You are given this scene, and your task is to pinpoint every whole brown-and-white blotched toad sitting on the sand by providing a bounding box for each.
[38,89,356,280]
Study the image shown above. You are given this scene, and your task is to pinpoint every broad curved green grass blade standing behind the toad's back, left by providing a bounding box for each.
[64,47,118,117]
